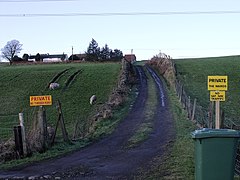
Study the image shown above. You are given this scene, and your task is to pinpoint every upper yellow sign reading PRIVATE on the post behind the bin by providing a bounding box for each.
[208,76,228,91]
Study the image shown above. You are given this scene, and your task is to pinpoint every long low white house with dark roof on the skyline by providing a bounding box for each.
[28,53,68,62]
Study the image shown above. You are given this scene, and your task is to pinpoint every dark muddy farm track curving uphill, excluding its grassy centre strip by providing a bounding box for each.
[0,66,174,179]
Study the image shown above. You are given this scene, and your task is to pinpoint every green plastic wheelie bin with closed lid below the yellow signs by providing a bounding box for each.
[191,128,240,180]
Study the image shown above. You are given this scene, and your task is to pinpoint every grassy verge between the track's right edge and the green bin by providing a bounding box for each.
[141,88,195,180]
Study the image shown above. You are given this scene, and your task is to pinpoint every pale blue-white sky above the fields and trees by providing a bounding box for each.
[0,0,240,60]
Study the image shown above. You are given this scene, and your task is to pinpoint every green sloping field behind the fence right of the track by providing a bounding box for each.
[174,56,240,124]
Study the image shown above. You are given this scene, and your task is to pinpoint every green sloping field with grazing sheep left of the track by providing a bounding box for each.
[0,63,121,139]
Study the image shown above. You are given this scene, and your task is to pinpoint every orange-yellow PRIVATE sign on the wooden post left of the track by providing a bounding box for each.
[30,95,52,106]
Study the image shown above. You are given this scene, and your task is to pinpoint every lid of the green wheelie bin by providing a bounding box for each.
[191,128,240,139]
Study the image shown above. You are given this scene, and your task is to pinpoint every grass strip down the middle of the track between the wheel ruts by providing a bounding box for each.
[127,67,157,148]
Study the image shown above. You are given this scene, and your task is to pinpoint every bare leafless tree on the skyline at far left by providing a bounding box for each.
[1,39,22,64]
